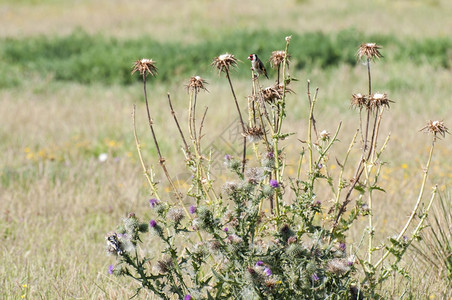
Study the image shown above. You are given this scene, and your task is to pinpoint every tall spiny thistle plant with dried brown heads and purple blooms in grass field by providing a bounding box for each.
[106,37,448,299]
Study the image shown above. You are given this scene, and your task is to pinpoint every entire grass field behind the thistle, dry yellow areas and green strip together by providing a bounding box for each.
[0,0,452,299]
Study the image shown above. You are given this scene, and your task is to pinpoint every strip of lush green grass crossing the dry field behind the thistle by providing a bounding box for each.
[0,29,452,87]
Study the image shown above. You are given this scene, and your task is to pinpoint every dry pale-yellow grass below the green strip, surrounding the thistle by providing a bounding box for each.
[0,62,452,299]
